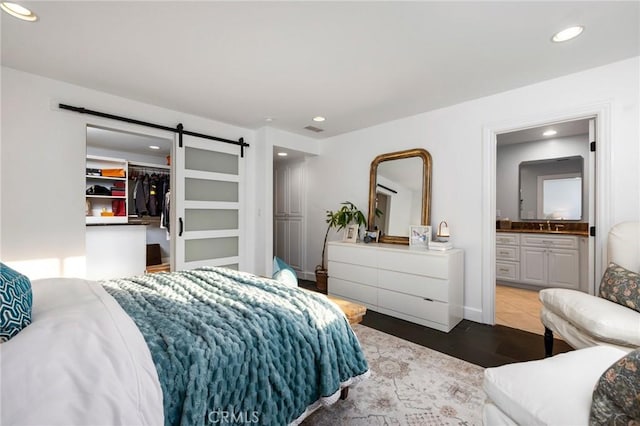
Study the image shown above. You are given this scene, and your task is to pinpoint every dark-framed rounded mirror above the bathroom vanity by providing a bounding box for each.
[519,155,585,221]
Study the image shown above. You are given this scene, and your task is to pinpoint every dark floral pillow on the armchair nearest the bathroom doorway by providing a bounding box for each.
[600,263,640,312]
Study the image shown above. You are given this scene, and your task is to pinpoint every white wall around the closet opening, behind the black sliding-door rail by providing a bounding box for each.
[0,68,261,278]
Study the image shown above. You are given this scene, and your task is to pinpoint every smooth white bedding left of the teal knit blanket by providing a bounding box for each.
[0,278,164,426]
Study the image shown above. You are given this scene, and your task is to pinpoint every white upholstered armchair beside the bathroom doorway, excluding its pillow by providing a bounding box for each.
[540,222,640,356]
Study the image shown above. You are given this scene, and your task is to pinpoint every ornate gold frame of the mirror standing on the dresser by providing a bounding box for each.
[367,148,431,245]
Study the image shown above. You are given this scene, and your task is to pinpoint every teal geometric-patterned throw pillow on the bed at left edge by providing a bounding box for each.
[0,263,33,343]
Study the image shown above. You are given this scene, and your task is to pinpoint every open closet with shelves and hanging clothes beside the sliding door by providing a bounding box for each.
[85,126,172,279]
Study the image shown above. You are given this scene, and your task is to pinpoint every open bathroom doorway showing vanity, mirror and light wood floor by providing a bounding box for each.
[493,117,596,334]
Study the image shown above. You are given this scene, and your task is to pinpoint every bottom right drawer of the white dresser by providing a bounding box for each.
[378,289,449,324]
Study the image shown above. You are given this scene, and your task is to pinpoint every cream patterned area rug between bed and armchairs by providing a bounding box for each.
[302,325,486,426]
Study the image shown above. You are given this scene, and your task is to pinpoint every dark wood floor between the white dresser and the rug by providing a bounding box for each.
[300,280,572,367]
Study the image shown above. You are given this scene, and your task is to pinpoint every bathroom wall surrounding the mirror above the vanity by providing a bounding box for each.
[496,135,589,221]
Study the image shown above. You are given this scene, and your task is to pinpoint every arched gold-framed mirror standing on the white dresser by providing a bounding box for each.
[368,148,431,244]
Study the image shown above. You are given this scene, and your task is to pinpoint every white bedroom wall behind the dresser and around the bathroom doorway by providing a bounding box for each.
[307,57,640,321]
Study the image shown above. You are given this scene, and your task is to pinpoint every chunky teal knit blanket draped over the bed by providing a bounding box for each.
[101,267,368,425]
